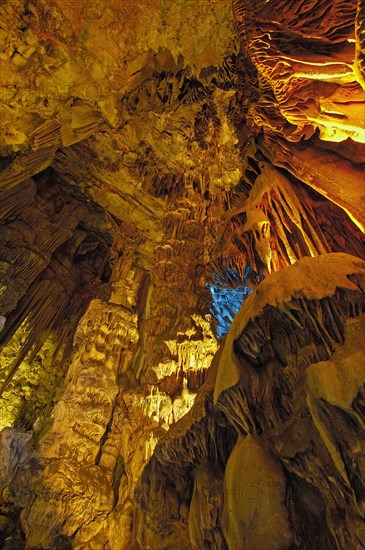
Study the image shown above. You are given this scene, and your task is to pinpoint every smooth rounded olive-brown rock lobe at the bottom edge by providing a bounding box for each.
[224,436,292,550]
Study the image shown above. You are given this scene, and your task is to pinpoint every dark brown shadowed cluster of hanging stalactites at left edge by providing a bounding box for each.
[0,172,111,406]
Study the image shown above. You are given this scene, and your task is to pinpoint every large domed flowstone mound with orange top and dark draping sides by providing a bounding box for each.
[137,254,365,549]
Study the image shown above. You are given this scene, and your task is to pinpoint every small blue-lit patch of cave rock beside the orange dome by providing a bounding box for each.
[208,267,253,339]
